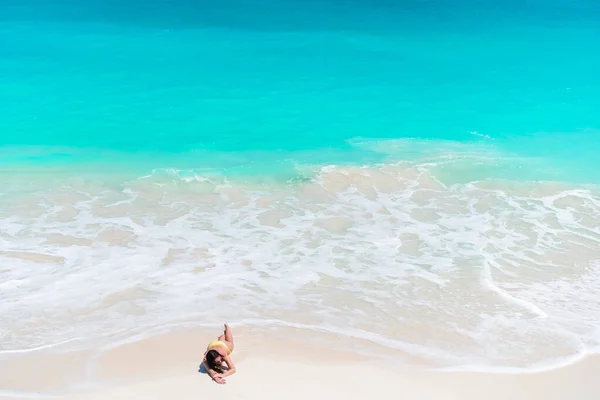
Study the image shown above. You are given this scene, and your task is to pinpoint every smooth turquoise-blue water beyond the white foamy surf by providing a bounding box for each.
[0,0,600,182]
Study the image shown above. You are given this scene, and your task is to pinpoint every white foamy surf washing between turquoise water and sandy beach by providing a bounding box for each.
[0,163,600,369]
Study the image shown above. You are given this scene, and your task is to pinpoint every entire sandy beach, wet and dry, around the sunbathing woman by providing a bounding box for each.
[0,327,600,400]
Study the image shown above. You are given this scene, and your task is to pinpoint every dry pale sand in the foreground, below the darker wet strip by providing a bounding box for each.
[72,357,600,400]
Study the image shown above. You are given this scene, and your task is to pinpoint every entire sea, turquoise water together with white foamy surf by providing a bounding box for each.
[0,0,600,382]
